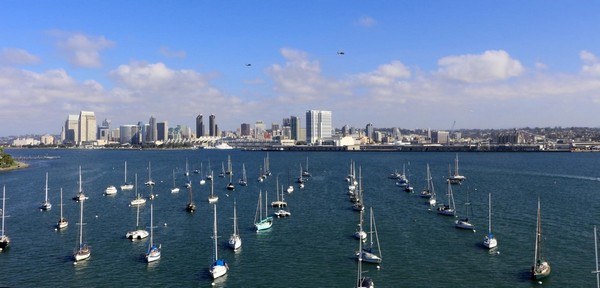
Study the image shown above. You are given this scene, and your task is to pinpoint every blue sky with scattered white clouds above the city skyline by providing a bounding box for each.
[0,0,600,136]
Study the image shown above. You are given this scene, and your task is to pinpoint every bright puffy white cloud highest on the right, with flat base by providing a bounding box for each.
[436,50,525,83]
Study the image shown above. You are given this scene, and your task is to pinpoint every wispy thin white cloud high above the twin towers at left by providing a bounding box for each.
[50,31,115,68]
